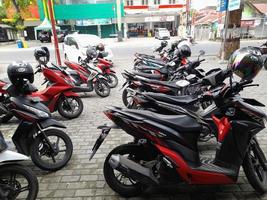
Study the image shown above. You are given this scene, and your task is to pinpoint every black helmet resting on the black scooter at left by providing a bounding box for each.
[7,61,34,87]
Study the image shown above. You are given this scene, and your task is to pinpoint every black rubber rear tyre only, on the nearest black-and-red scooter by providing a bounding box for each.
[103,144,148,197]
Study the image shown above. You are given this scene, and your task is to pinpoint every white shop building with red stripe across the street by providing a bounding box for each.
[124,0,185,37]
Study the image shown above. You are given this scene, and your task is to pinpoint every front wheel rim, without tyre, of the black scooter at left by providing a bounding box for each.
[38,135,67,164]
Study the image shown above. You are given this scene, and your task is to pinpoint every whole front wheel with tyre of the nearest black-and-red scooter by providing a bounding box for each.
[242,138,267,194]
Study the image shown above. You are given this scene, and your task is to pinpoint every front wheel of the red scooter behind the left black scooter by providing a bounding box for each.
[57,96,83,119]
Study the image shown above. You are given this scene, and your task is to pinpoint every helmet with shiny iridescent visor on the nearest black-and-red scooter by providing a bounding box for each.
[227,47,263,80]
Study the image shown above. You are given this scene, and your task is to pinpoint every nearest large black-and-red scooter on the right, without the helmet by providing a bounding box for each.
[90,77,267,197]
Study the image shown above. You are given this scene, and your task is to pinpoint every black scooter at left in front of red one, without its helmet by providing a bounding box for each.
[3,82,73,171]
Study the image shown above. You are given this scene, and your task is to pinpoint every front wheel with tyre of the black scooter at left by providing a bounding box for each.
[30,129,73,171]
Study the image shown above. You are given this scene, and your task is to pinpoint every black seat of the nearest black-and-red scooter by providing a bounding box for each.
[128,109,202,133]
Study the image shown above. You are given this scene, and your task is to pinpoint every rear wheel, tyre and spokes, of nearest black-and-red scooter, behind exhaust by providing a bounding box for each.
[104,144,154,197]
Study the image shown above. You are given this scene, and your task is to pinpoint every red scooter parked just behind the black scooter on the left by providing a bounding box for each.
[0,64,83,122]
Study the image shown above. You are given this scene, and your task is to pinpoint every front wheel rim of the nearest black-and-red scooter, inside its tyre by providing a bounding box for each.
[249,148,267,184]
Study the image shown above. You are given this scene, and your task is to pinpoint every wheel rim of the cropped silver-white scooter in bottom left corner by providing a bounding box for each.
[0,171,30,200]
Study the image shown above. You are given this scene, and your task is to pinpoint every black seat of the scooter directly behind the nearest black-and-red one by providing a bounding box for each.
[142,92,198,106]
